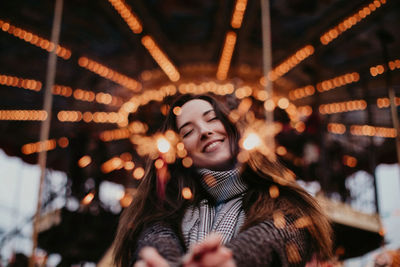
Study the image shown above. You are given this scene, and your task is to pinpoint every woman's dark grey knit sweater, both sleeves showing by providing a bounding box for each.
[132,219,311,267]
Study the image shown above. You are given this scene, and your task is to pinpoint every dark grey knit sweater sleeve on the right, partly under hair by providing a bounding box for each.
[226,220,311,267]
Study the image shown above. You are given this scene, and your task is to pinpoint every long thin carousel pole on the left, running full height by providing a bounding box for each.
[29,0,63,267]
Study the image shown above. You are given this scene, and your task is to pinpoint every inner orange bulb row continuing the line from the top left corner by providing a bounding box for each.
[78,57,142,92]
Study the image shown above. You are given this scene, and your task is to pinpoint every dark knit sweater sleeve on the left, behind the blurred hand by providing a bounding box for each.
[131,223,185,266]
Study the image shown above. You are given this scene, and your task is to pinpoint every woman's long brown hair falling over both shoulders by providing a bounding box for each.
[114,94,332,266]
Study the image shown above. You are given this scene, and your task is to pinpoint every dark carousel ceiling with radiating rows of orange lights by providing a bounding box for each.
[0,0,400,197]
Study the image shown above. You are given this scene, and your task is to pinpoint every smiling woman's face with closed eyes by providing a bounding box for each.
[176,99,232,170]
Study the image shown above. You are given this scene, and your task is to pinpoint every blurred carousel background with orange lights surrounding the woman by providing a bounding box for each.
[0,0,400,266]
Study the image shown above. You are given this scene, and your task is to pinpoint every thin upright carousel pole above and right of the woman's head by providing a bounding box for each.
[261,0,275,147]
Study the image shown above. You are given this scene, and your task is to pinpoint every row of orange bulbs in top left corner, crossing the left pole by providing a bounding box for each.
[0,19,72,60]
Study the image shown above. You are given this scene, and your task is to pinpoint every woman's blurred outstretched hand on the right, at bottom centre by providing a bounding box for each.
[183,234,236,267]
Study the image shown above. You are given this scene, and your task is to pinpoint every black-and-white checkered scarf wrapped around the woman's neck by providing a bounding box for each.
[182,169,247,248]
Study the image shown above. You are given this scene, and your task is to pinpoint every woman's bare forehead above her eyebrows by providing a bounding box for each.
[176,99,213,127]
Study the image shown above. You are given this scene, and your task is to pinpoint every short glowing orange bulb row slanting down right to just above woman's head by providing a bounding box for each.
[142,35,180,82]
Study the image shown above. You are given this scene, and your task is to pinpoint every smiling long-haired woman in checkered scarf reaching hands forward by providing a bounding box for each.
[114,95,331,266]
